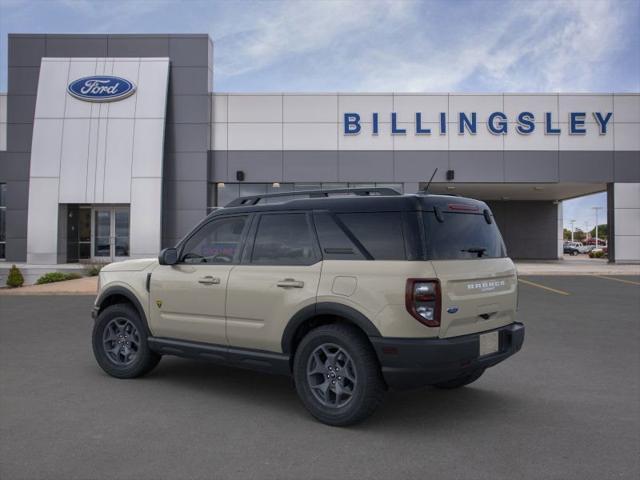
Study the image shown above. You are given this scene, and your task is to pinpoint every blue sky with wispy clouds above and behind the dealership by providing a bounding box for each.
[0,0,640,225]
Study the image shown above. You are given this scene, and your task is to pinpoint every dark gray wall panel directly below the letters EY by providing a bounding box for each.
[559,151,613,183]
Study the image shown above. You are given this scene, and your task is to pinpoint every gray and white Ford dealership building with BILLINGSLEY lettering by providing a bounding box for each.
[0,34,640,265]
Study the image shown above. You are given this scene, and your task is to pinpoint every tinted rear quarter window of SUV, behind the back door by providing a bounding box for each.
[337,212,407,260]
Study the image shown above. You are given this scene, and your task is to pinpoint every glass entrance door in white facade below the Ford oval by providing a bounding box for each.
[92,207,129,262]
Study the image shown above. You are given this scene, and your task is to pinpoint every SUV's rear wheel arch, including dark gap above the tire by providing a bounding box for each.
[281,302,382,355]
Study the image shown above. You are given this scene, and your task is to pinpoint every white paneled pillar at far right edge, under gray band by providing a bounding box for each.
[613,183,640,263]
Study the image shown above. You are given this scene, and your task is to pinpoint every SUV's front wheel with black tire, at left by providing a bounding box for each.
[92,303,160,378]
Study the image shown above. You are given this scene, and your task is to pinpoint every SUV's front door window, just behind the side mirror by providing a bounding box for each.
[180,216,247,265]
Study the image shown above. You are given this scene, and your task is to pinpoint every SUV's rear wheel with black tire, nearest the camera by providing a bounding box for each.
[293,324,385,426]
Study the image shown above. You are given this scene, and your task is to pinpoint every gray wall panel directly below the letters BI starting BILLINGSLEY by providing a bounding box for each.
[338,150,393,182]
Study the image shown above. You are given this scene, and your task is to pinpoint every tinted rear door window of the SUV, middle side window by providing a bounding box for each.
[251,213,319,265]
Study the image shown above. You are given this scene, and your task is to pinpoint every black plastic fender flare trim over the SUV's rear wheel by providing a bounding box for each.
[281,302,382,353]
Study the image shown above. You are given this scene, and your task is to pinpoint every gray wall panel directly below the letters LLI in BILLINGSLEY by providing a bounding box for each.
[393,150,449,182]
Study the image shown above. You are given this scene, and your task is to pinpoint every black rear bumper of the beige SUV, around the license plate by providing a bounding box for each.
[370,323,524,390]
